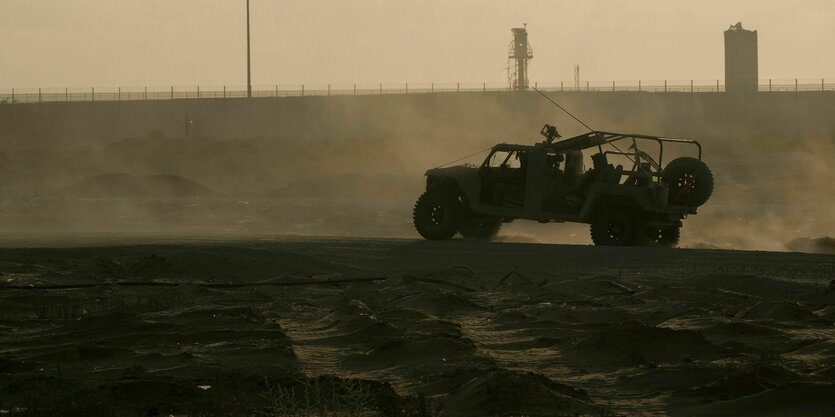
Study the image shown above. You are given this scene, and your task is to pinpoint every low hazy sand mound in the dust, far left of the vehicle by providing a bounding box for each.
[56,174,217,199]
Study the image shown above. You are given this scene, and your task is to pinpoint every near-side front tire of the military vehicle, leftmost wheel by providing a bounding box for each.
[412,189,464,240]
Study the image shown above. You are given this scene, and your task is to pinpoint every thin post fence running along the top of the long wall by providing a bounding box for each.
[0,78,835,104]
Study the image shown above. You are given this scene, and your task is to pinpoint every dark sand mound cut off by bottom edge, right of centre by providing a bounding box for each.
[443,369,598,416]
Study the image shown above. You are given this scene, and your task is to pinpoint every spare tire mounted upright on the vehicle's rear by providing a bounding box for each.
[661,157,713,207]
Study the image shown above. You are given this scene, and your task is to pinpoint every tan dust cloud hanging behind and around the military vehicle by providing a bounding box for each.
[0,93,835,251]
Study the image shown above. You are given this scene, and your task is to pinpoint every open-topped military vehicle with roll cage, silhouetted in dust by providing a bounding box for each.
[413,125,713,247]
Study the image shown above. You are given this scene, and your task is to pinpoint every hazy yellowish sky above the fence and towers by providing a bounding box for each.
[0,0,835,88]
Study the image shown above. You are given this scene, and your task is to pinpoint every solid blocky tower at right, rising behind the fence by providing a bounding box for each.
[725,22,759,93]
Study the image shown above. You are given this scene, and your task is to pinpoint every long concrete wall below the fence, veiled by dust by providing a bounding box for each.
[0,92,835,149]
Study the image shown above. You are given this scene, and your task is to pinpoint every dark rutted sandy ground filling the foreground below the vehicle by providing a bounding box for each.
[0,239,835,416]
